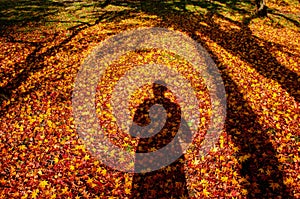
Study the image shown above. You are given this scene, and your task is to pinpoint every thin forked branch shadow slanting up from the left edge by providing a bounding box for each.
[0,7,135,116]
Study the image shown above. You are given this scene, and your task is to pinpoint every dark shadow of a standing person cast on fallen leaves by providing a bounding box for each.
[130,81,192,198]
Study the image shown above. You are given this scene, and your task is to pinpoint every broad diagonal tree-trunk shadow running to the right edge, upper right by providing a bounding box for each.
[134,1,300,102]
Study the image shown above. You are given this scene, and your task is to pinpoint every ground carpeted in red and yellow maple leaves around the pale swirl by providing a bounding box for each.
[0,0,300,198]
